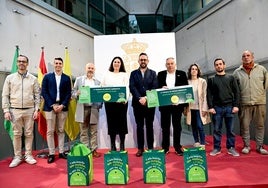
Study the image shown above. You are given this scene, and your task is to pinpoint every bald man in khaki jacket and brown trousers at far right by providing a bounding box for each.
[234,50,268,155]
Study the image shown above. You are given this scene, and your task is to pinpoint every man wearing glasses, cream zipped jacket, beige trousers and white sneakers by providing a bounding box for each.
[2,55,40,168]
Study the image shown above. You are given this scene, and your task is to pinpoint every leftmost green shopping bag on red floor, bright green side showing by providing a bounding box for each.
[67,142,93,186]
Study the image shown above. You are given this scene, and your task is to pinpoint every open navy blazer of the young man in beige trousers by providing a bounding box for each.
[41,72,72,111]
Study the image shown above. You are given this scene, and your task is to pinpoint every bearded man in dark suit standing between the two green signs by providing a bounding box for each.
[129,53,158,157]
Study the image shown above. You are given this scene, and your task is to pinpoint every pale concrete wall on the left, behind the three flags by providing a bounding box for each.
[0,0,94,76]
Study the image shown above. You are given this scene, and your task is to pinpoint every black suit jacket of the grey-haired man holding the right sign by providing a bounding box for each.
[157,70,188,111]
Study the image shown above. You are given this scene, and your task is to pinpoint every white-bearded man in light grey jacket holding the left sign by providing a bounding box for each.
[72,63,101,158]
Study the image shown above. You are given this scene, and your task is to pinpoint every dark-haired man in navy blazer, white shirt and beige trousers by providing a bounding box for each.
[41,58,72,163]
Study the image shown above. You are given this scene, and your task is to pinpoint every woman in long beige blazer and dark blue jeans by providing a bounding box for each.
[186,63,211,148]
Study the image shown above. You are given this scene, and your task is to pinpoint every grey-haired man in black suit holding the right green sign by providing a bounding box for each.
[157,57,188,155]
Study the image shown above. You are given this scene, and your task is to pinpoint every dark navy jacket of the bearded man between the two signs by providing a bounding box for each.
[129,68,158,107]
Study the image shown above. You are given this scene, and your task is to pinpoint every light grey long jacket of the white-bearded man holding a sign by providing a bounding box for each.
[72,75,102,124]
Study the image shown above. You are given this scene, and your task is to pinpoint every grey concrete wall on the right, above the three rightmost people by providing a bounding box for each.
[175,0,268,73]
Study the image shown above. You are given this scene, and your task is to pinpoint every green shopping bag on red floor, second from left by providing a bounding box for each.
[104,151,129,185]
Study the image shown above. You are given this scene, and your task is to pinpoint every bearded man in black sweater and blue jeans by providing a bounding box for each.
[207,58,240,157]
